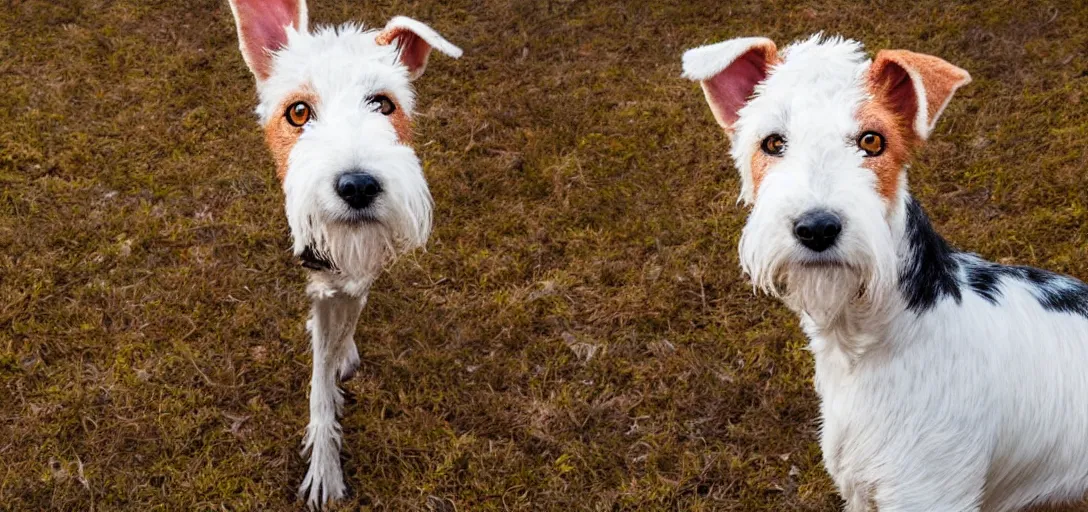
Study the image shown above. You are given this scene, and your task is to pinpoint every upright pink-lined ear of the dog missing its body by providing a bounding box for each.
[230,0,307,82]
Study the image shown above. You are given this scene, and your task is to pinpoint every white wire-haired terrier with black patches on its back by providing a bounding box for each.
[683,36,1088,512]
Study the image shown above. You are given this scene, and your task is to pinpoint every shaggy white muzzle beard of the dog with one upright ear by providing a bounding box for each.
[284,148,432,293]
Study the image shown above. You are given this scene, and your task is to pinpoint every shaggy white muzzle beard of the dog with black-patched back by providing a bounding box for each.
[740,196,898,327]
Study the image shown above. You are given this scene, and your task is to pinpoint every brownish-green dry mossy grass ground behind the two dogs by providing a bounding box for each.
[0,0,1088,512]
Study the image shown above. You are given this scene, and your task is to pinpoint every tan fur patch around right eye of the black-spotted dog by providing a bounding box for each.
[856,83,922,203]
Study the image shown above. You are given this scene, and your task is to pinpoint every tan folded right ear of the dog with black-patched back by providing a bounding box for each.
[869,50,970,139]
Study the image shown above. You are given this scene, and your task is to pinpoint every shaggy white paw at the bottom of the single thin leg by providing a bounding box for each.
[298,425,347,510]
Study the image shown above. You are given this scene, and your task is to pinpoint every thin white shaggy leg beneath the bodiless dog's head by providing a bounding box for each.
[299,291,366,509]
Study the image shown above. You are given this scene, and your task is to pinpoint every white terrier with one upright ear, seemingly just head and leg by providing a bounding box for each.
[231,0,461,508]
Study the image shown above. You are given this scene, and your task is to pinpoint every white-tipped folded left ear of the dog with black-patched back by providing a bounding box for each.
[683,37,778,133]
